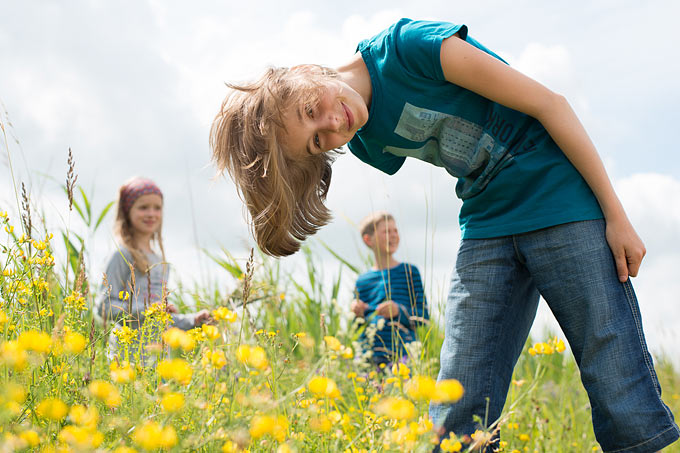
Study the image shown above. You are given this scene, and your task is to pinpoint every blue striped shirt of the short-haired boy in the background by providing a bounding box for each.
[355,263,430,358]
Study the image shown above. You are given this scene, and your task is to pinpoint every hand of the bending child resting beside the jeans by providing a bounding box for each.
[605,217,647,283]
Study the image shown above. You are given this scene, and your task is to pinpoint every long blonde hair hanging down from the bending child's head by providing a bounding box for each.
[210,66,336,256]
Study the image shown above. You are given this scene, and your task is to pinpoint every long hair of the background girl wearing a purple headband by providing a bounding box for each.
[113,177,165,273]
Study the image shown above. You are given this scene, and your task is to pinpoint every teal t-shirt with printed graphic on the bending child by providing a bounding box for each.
[349,19,602,239]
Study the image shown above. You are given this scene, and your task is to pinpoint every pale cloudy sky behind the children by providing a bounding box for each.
[0,0,680,363]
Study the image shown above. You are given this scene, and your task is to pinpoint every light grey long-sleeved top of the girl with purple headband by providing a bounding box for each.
[95,246,196,357]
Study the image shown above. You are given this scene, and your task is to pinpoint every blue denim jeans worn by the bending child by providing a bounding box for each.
[430,220,680,453]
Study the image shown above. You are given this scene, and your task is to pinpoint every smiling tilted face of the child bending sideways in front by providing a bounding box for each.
[281,79,368,160]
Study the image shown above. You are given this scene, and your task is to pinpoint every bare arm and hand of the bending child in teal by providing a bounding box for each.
[440,35,646,282]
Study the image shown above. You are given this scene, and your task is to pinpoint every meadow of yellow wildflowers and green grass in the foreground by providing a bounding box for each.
[0,207,680,453]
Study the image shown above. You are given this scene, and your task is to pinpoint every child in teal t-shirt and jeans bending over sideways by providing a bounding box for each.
[211,19,680,453]
